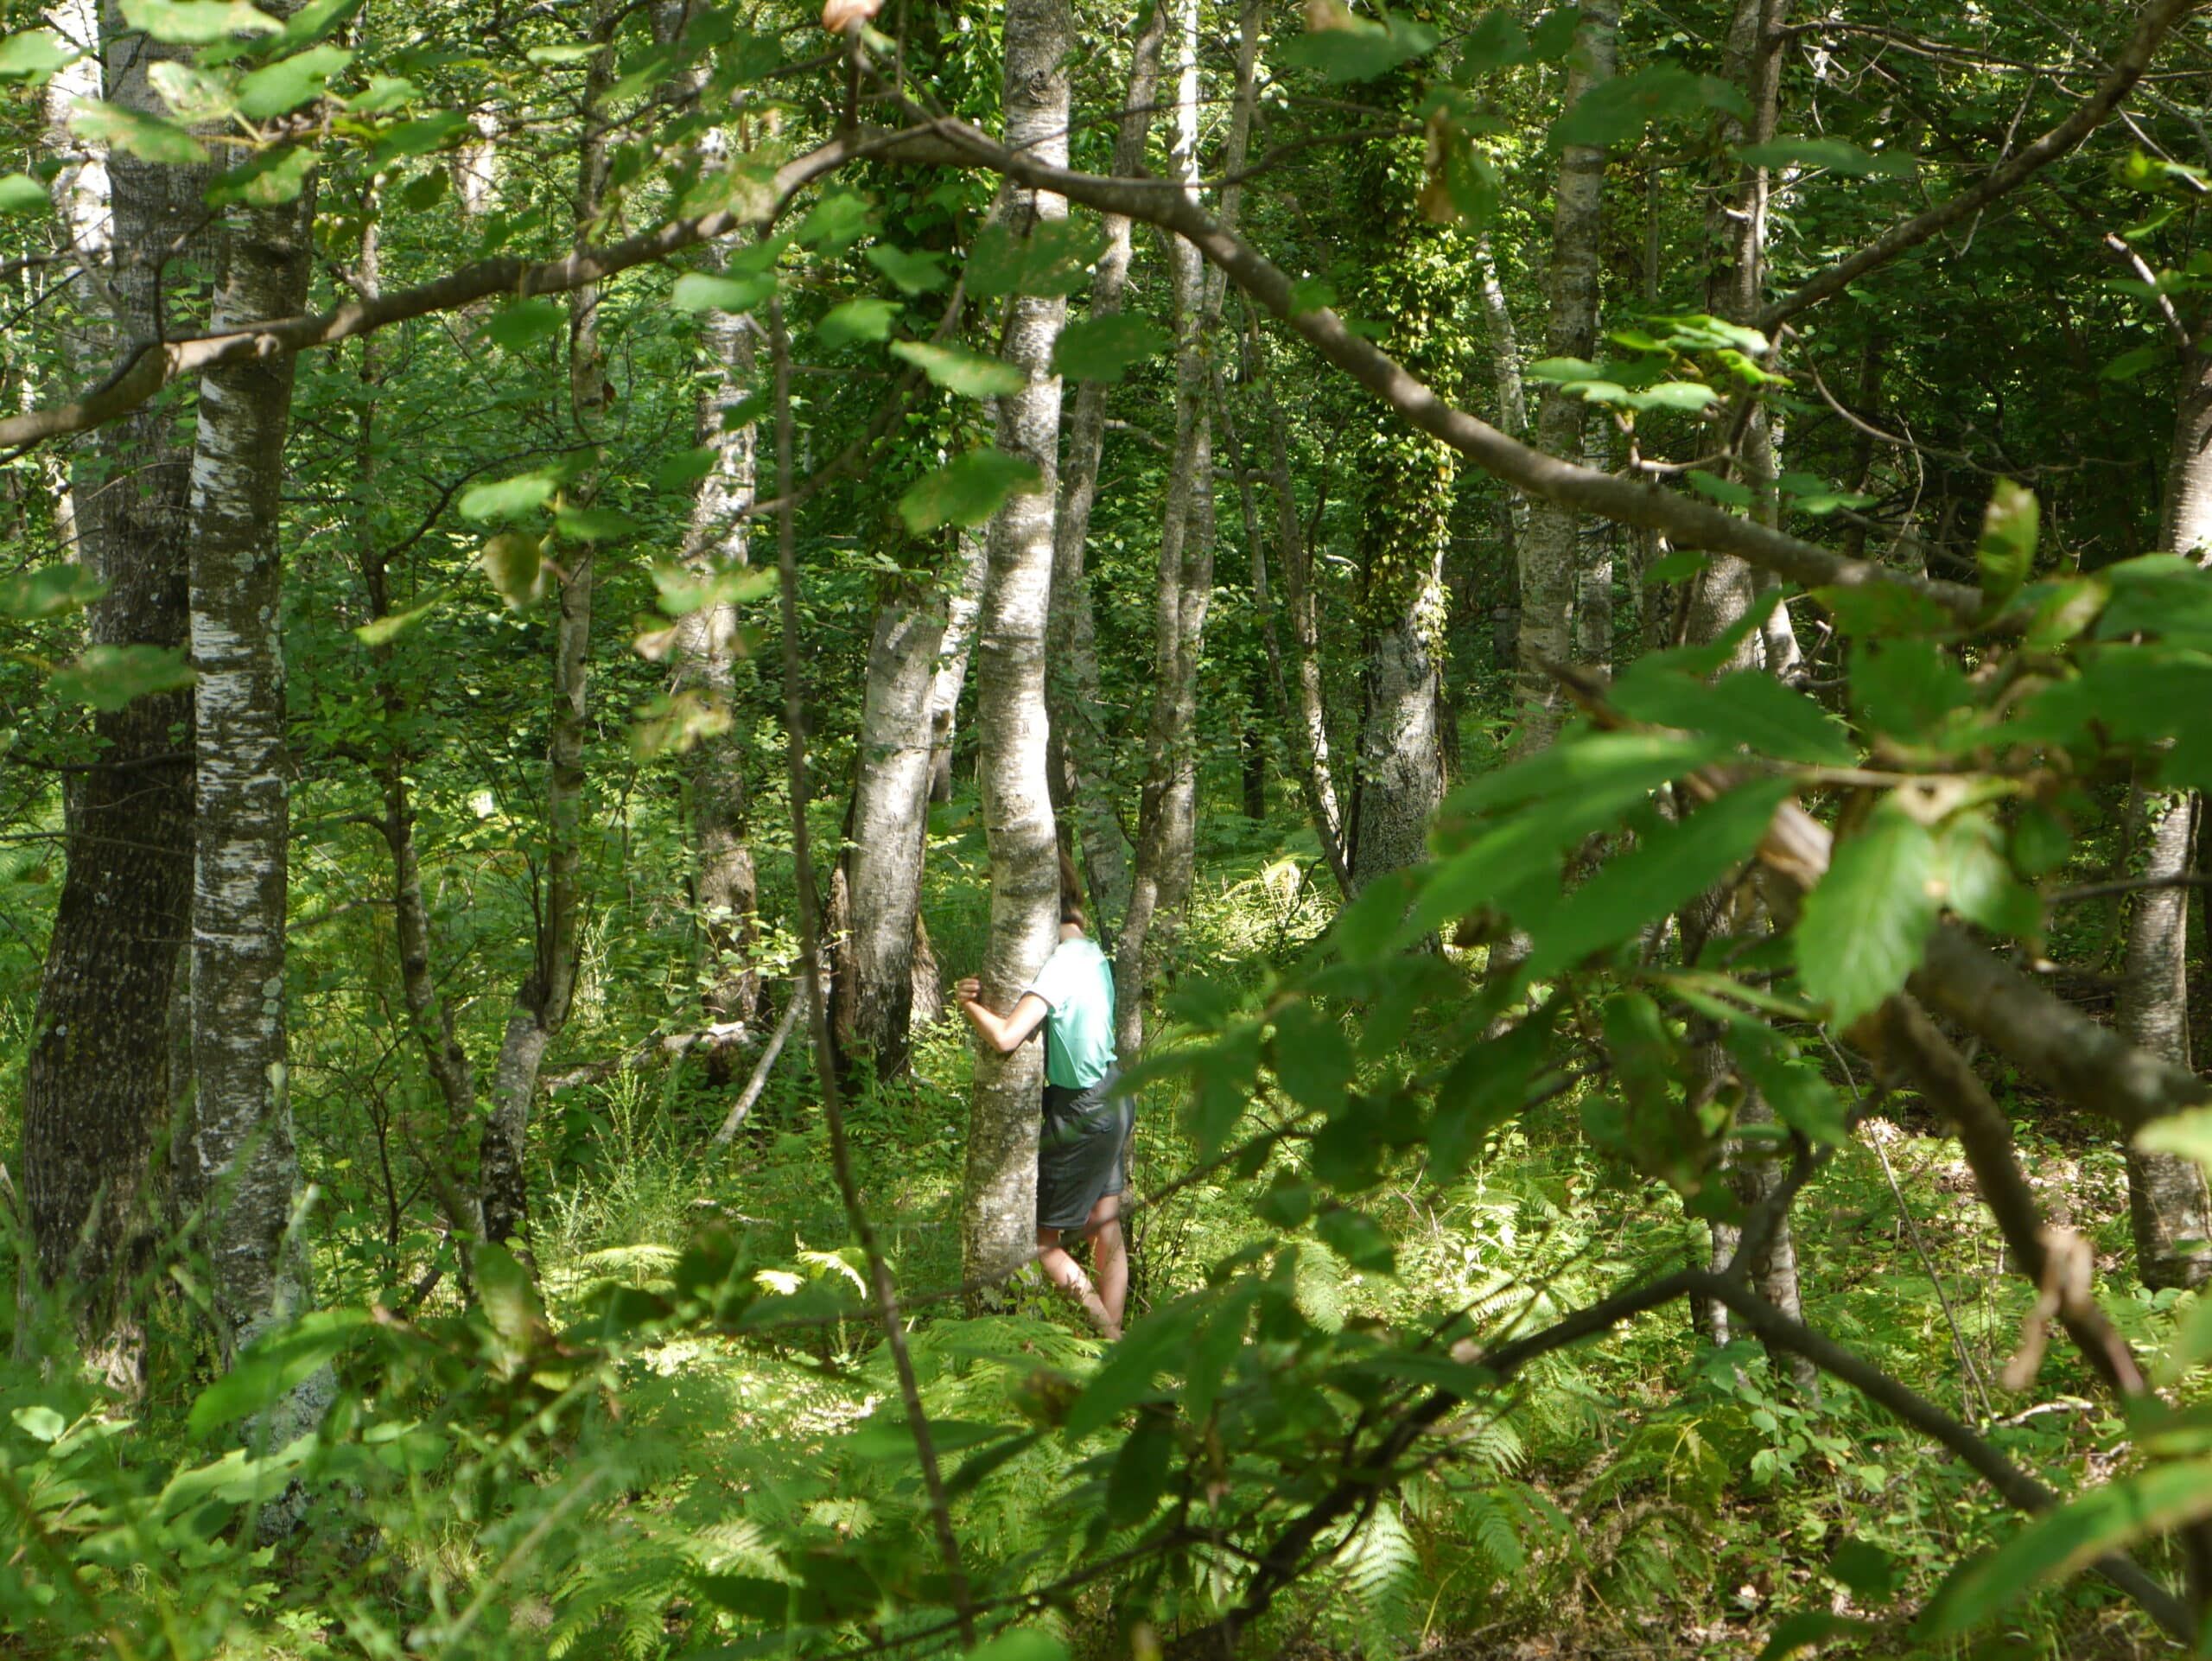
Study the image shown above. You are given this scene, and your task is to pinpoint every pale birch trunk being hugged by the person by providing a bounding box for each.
[960,0,1071,1285]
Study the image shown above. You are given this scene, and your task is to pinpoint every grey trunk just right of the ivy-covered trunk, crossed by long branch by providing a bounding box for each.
[1516,0,1621,750]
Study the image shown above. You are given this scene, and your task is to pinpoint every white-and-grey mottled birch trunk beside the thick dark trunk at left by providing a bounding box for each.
[193,179,329,1389]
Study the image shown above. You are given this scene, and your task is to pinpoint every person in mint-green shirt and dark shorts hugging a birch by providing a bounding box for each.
[953,854,1137,1338]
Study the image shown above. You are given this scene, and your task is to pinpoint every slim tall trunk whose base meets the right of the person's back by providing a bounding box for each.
[1113,0,1241,1060]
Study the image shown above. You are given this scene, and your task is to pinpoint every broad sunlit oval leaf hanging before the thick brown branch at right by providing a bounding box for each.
[1792,807,1942,1028]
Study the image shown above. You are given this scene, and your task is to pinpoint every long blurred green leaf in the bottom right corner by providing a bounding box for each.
[1913,1460,2212,1644]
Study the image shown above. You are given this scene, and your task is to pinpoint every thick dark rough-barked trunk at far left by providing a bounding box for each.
[17,7,208,1387]
